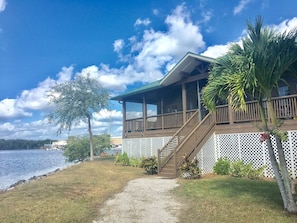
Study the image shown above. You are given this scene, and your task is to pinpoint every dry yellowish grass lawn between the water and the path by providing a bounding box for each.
[0,158,144,223]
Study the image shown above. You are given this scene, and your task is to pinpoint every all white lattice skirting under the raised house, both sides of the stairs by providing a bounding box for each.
[123,131,297,178]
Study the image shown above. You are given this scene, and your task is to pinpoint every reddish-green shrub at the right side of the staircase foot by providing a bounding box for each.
[179,156,201,179]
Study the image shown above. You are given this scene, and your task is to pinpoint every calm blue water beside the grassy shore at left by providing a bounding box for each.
[0,150,70,190]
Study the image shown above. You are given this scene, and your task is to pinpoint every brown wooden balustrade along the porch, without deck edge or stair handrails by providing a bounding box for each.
[125,95,297,132]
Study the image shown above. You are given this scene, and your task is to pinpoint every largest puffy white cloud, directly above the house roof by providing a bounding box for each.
[80,4,205,92]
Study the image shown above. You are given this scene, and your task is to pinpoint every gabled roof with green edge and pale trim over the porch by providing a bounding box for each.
[111,52,215,101]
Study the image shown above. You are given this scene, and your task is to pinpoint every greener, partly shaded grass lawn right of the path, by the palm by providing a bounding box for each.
[174,176,297,223]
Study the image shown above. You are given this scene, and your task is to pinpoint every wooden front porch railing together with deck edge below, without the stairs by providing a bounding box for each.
[123,94,297,138]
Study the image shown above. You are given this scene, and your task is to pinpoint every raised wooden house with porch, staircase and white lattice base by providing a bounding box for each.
[112,53,297,178]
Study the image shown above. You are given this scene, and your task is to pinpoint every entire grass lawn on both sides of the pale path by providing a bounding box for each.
[0,160,297,223]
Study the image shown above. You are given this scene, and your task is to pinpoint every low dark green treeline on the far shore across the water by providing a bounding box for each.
[0,139,53,150]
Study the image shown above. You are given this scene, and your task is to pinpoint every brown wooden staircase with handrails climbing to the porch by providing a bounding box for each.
[158,111,215,178]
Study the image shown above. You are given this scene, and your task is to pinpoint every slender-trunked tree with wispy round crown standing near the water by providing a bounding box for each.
[47,76,110,160]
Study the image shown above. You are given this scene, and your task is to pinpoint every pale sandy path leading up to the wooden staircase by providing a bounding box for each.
[93,177,181,223]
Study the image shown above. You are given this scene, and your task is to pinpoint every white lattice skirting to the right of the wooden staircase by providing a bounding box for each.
[197,131,297,178]
